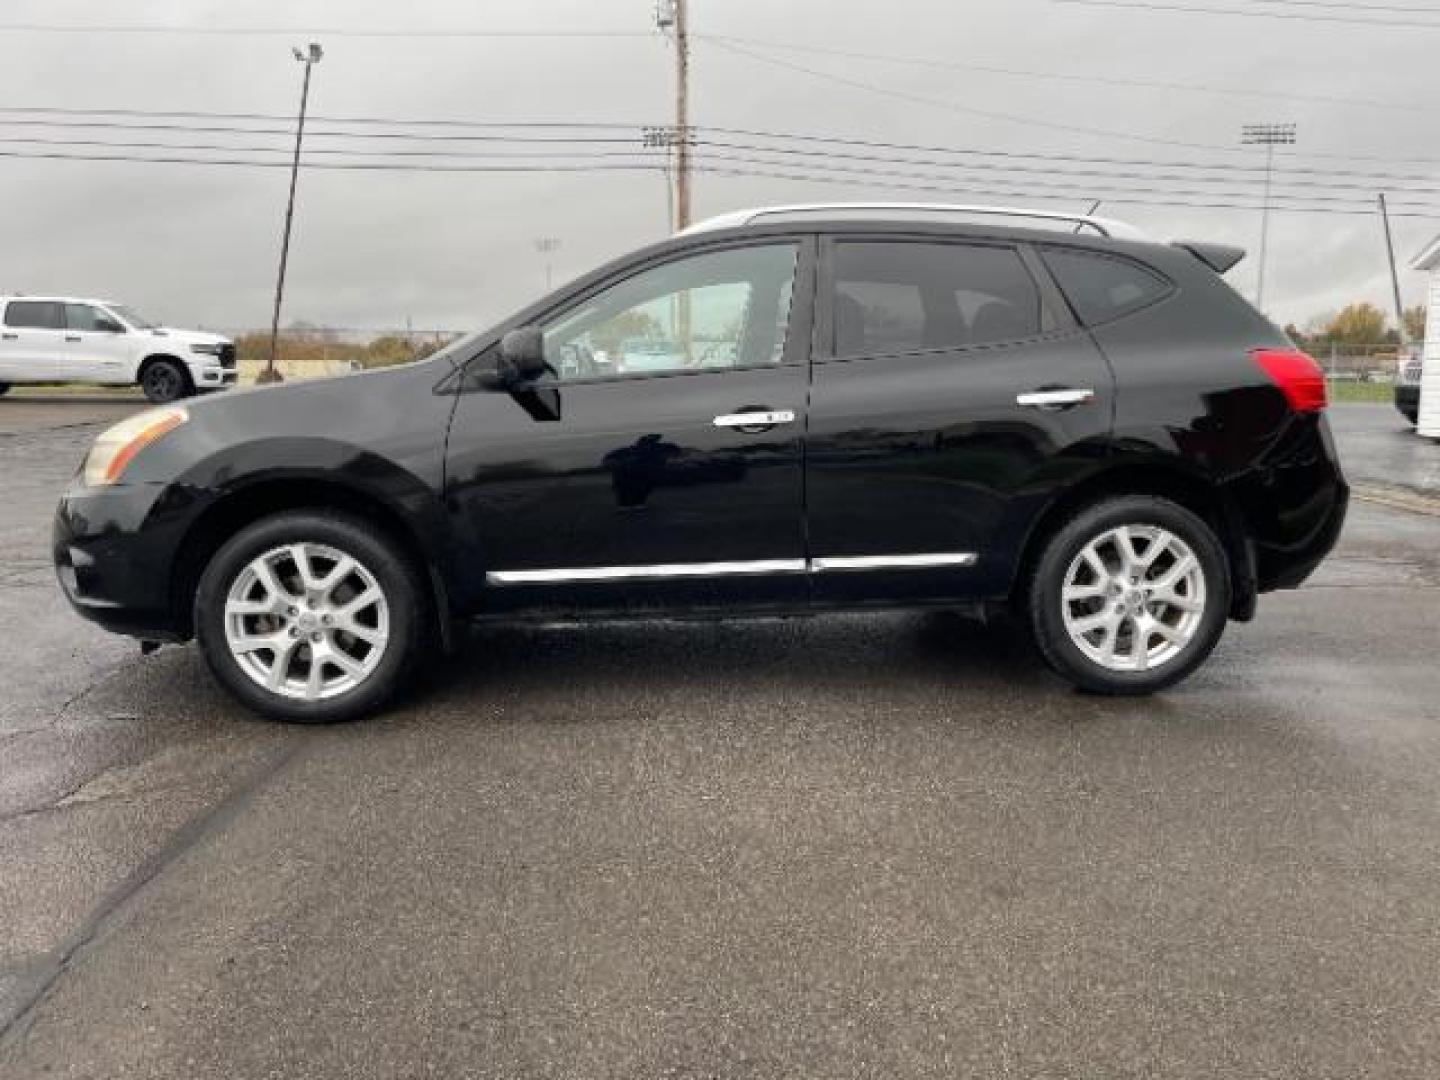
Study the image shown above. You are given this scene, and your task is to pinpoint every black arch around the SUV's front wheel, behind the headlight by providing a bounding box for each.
[170,477,452,651]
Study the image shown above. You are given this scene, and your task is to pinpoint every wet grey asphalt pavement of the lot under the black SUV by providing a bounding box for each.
[0,399,1440,1079]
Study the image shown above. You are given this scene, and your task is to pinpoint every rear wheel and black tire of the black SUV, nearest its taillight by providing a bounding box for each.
[1025,495,1230,694]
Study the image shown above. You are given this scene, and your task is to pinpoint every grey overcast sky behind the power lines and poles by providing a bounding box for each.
[0,0,1440,328]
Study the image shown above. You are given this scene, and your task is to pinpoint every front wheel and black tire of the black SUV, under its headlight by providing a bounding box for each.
[194,511,429,723]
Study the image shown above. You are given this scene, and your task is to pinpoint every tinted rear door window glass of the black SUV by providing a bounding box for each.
[831,240,1050,357]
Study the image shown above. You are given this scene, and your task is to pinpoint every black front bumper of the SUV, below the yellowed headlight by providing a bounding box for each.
[52,481,186,641]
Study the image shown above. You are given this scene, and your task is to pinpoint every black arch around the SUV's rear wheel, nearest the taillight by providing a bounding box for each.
[1009,462,1259,622]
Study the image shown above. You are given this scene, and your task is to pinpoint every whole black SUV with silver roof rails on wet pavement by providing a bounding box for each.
[55,206,1348,720]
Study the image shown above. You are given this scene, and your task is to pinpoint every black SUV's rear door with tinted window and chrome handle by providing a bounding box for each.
[806,235,1113,602]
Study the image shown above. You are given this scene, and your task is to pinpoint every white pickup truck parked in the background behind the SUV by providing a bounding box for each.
[0,297,235,402]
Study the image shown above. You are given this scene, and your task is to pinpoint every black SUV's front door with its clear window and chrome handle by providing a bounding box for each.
[446,238,814,612]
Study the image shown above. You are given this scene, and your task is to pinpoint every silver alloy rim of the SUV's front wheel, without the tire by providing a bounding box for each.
[225,543,390,701]
